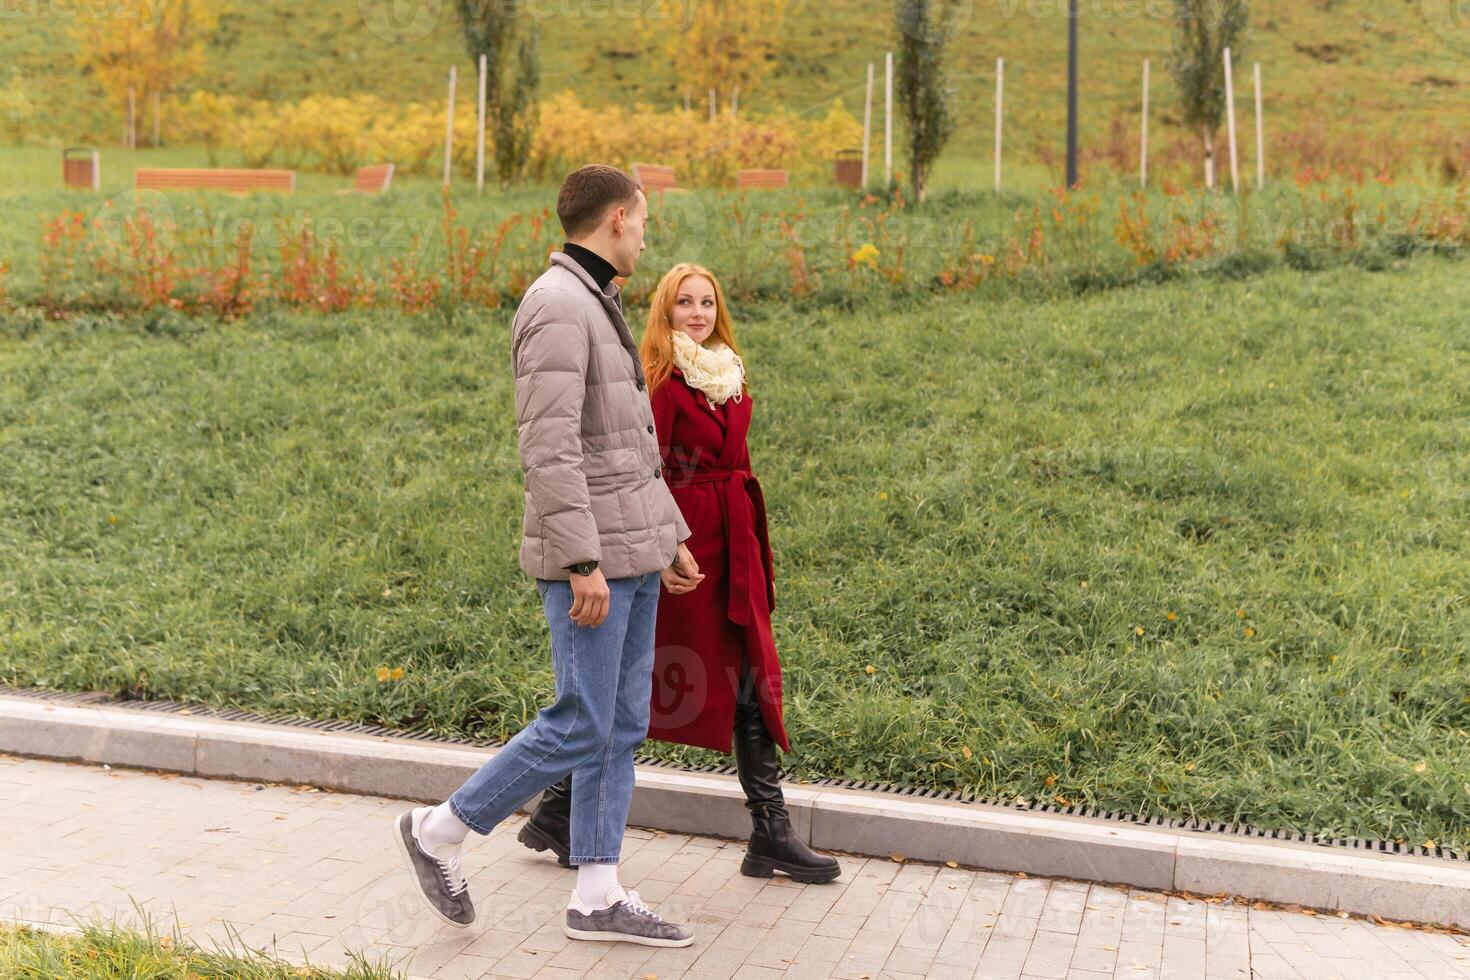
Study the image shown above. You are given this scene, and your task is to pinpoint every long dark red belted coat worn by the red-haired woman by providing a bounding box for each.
[648,369,791,752]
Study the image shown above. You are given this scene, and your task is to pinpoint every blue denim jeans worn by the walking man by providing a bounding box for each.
[450,572,660,864]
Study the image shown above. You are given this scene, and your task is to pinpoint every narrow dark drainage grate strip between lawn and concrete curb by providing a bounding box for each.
[0,685,1470,864]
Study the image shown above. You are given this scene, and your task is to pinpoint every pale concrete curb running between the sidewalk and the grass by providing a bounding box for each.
[0,696,1470,929]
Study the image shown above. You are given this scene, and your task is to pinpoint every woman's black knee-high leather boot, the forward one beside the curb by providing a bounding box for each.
[735,698,842,883]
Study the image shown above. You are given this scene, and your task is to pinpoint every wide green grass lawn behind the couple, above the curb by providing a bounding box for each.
[0,257,1470,848]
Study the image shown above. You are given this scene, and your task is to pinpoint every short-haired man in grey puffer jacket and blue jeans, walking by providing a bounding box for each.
[394,165,704,946]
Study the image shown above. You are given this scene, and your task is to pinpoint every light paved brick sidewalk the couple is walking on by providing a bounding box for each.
[0,755,1470,980]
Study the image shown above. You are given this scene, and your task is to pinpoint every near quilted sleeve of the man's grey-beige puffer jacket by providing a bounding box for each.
[512,291,603,569]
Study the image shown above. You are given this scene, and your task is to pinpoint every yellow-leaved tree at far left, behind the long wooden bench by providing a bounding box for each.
[72,0,219,144]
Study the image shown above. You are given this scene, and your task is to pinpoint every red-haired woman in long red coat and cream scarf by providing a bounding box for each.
[520,263,842,882]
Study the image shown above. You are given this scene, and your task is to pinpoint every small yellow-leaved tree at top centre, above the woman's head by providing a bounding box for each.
[642,0,791,106]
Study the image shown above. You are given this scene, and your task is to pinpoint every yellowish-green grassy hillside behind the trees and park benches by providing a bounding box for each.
[0,0,1470,184]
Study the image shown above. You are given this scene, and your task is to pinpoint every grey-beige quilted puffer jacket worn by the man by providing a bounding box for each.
[510,251,689,579]
